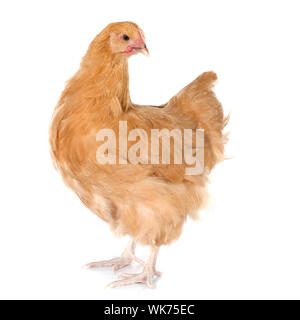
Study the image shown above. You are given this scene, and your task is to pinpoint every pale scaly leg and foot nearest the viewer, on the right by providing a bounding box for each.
[106,246,161,288]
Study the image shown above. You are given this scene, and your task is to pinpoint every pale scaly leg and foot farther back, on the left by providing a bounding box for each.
[84,240,144,271]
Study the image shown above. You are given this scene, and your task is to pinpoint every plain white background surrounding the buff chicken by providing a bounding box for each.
[0,0,300,299]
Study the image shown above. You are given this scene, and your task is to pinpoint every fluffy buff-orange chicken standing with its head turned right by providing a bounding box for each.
[50,22,227,287]
